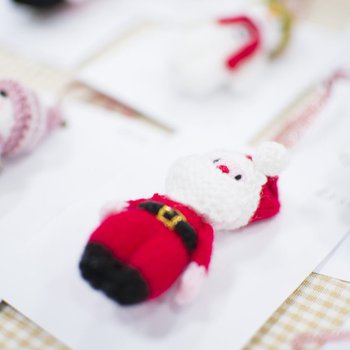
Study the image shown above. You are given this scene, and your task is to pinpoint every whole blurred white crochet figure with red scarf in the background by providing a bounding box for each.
[172,0,292,95]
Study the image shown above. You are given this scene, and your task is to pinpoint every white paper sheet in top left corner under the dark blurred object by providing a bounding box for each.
[0,0,137,68]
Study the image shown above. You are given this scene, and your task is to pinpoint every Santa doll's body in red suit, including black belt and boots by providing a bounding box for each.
[80,194,213,304]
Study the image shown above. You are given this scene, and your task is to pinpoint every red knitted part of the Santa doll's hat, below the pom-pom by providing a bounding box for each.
[249,176,281,223]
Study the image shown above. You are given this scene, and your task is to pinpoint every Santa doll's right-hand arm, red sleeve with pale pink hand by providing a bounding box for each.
[175,224,214,305]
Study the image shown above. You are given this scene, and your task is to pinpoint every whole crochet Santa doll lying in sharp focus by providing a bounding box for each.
[80,142,286,305]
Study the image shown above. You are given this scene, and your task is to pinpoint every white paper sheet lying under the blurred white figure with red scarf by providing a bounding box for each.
[80,22,342,131]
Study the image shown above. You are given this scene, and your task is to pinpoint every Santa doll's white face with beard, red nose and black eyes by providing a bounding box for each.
[166,152,267,230]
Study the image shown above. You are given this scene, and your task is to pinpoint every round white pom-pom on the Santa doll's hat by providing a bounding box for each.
[253,141,288,176]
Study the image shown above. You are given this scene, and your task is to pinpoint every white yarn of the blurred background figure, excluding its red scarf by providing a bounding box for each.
[172,6,281,95]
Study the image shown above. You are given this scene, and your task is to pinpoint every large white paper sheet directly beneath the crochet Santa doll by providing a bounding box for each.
[0,89,349,350]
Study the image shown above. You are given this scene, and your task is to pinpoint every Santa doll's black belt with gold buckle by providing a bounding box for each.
[139,201,197,253]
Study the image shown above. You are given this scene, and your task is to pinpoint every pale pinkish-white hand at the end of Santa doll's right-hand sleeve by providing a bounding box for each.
[175,262,206,305]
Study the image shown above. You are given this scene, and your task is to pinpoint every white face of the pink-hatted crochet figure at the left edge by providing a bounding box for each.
[0,87,15,148]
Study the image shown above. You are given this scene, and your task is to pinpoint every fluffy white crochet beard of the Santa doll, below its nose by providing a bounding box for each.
[166,156,261,230]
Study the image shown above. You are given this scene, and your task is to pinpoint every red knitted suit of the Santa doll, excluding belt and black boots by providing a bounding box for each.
[89,194,213,299]
